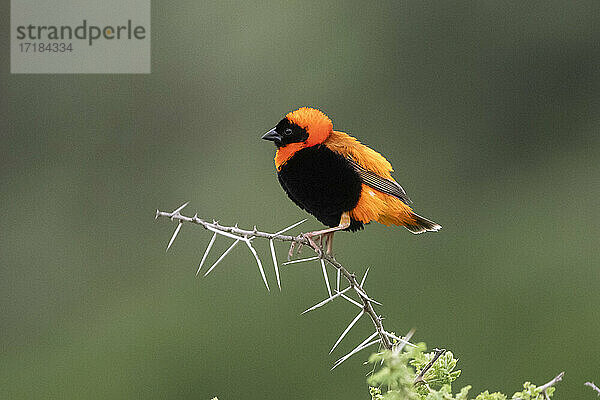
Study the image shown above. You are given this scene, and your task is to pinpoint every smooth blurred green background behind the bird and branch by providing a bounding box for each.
[0,0,600,400]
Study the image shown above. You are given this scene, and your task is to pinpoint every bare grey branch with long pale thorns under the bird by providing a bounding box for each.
[156,203,414,369]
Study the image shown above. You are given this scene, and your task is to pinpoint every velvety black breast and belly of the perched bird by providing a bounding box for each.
[278,145,362,231]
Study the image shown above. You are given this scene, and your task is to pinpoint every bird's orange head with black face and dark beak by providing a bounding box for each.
[262,107,333,168]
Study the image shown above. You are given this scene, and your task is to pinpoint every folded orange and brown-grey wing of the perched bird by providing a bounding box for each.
[323,131,411,204]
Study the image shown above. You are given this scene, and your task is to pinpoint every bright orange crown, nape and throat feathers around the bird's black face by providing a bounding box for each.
[275,107,333,168]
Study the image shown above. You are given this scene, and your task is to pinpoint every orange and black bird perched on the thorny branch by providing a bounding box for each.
[262,107,442,253]
